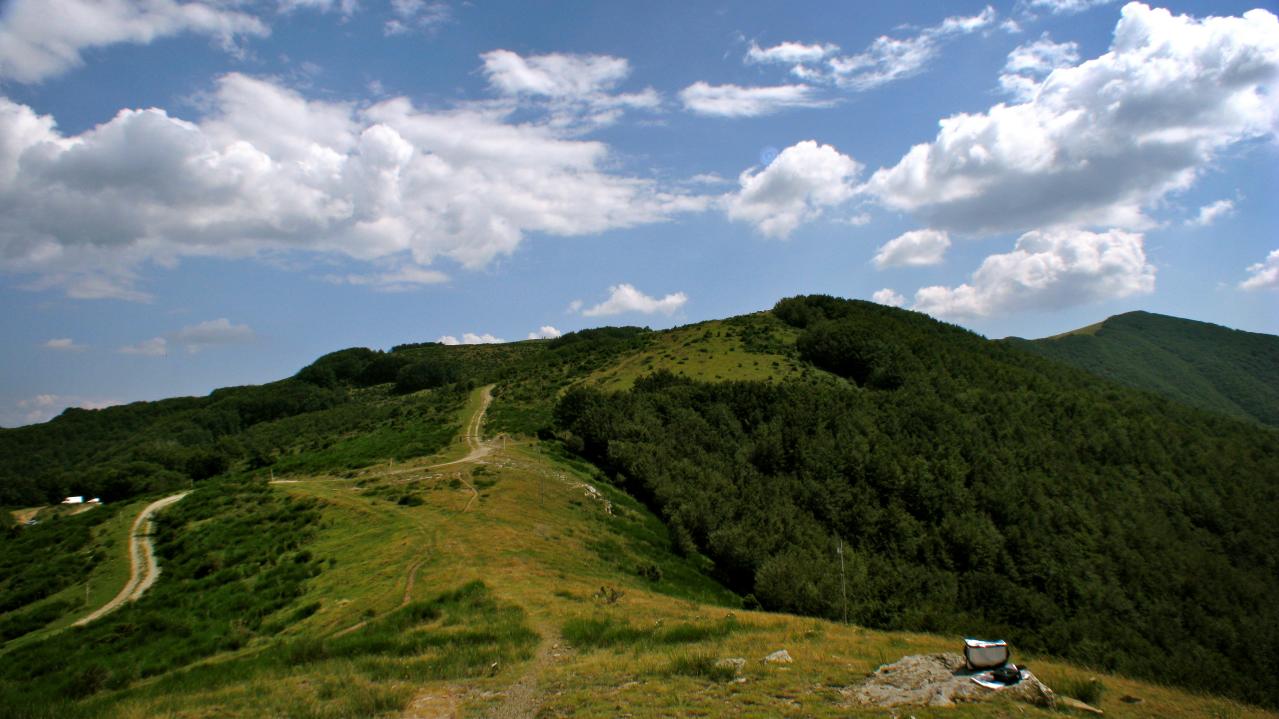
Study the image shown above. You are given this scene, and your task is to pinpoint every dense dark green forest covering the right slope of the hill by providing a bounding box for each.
[555,297,1279,706]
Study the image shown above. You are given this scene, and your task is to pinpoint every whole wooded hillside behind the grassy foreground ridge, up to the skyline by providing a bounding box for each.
[9,297,1279,706]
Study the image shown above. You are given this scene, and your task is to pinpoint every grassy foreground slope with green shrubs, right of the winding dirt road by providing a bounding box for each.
[0,388,1273,719]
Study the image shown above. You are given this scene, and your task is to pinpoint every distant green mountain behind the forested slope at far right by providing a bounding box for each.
[1009,312,1279,426]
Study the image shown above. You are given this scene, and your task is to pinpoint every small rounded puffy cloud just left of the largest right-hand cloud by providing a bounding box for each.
[723,139,861,238]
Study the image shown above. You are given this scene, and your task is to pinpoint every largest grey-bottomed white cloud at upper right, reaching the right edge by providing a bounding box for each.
[867,3,1279,233]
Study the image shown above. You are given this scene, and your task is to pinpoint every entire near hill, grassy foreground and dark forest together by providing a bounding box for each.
[0,297,1279,716]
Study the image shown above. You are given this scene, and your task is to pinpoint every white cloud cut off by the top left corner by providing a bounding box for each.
[0,0,270,83]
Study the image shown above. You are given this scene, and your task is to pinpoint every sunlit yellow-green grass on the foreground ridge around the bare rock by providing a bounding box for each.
[9,386,1273,719]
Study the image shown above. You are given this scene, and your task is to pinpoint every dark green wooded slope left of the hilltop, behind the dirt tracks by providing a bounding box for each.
[0,328,650,507]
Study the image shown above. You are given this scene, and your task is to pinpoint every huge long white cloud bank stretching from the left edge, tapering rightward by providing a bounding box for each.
[0,73,707,299]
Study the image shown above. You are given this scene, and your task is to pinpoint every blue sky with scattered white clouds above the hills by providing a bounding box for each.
[0,0,1279,426]
